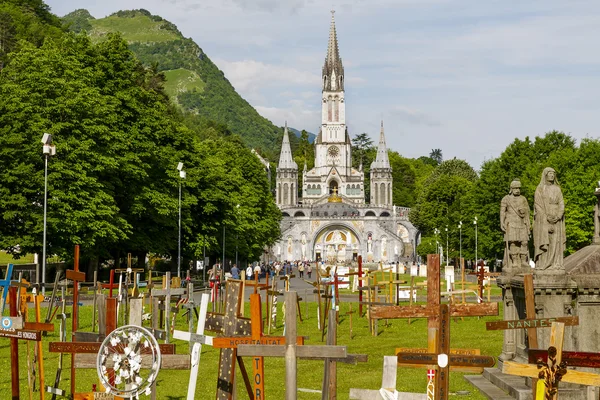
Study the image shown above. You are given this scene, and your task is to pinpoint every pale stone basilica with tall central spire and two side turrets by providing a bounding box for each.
[273,13,420,263]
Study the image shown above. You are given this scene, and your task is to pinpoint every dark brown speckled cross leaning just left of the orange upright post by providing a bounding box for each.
[205,279,252,400]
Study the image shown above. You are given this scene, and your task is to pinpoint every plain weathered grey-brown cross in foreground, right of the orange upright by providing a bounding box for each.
[237,292,347,400]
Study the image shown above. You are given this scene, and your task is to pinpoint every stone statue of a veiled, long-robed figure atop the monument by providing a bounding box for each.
[533,167,567,270]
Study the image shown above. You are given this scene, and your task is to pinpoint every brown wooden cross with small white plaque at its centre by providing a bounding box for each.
[397,304,496,400]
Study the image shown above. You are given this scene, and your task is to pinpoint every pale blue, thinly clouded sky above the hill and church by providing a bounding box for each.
[46,0,600,169]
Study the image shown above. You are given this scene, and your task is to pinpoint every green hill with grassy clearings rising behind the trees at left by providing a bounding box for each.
[63,10,282,158]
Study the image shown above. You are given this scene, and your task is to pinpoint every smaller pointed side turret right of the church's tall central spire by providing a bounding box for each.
[371,121,393,207]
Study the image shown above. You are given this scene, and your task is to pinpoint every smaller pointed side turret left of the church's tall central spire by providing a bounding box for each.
[275,122,298,207]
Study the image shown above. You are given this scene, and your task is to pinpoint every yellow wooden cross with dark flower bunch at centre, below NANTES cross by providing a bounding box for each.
[502,322,600,400]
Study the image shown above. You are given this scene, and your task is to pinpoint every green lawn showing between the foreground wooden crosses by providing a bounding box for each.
[0,290,502,400]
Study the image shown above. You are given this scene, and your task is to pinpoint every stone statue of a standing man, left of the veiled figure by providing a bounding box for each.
[500,179,531,268]
